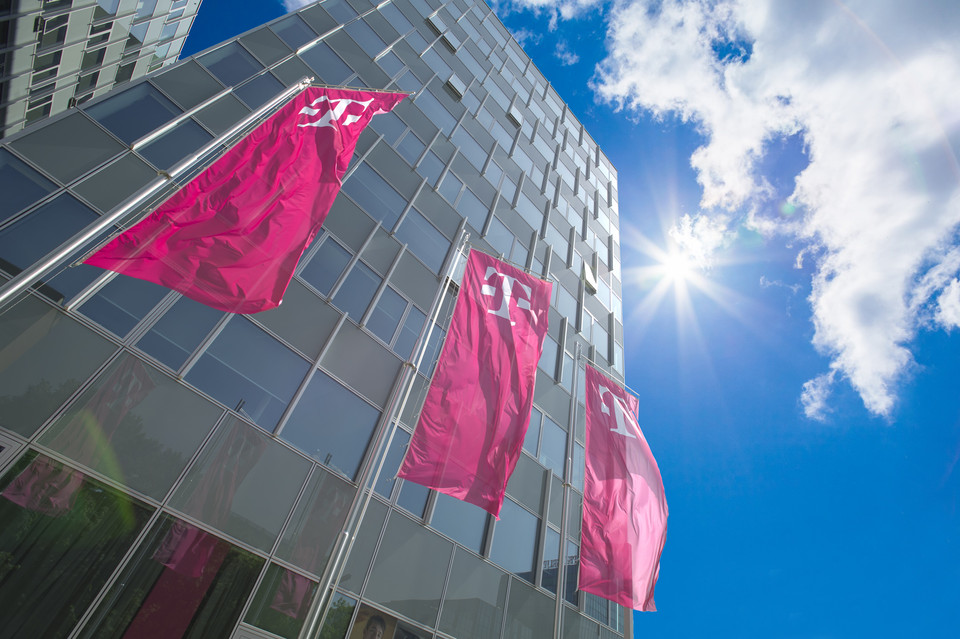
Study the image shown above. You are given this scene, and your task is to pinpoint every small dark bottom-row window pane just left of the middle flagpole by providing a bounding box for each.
[243,564,317,639]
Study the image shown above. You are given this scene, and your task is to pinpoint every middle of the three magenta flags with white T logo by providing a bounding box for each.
[398,251,552,517]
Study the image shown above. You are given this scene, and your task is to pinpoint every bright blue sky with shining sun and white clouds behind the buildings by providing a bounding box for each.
[185,0,960,639]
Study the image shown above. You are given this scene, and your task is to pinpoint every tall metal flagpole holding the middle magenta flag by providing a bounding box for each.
[299,231,470,639]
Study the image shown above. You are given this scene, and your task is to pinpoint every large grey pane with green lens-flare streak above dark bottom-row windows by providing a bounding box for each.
[40,355,220,499]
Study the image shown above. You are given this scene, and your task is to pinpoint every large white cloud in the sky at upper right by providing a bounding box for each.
[596,0,960,416]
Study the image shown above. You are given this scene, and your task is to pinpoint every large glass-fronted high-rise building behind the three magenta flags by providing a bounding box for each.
[0,0,624,639]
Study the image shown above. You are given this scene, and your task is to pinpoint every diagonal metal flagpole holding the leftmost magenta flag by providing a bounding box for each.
[0,77,313,316]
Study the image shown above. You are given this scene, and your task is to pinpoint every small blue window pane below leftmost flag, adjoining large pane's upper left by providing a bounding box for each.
[137,297,224,370]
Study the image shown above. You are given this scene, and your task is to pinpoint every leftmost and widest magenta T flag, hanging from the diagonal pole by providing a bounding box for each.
[85,87,405,313]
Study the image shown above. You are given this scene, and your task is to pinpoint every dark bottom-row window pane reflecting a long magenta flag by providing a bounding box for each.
[81,516,264,639]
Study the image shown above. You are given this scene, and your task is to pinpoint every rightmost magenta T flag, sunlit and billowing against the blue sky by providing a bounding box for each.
[579,365,667,610]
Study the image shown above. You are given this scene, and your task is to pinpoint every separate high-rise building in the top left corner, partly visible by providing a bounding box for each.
[0,0,201,138]
